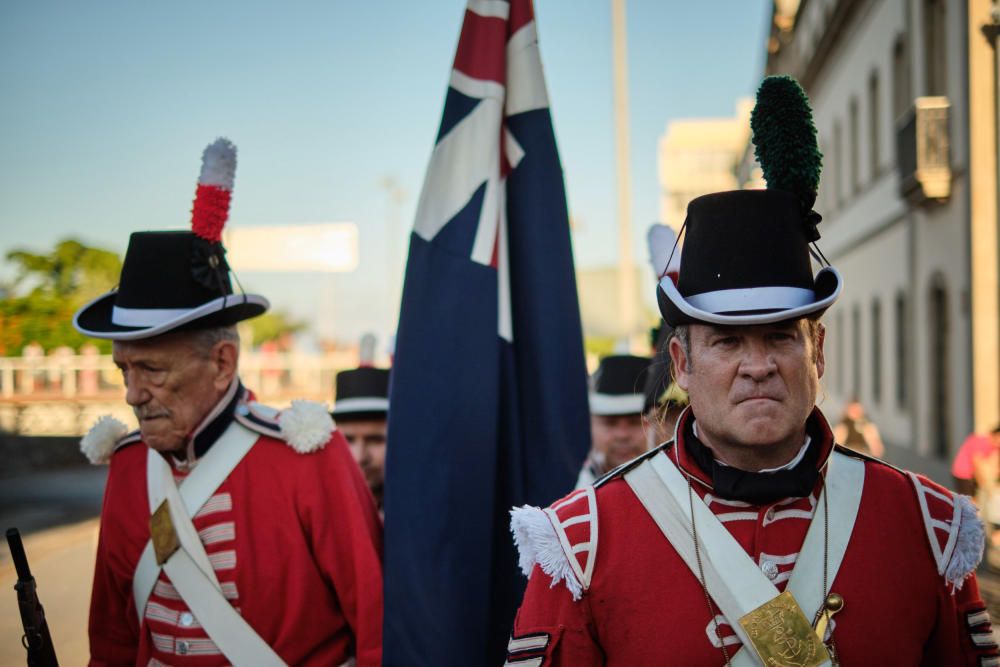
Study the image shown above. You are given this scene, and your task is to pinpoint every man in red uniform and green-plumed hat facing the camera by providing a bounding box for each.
[507,77,1000,667]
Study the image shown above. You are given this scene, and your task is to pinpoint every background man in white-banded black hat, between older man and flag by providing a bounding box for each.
[332,366,389,509]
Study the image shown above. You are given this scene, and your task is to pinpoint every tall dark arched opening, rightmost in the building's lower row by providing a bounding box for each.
[927,276,951,459]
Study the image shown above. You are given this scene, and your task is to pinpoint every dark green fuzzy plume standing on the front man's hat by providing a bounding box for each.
[750,76,823,202]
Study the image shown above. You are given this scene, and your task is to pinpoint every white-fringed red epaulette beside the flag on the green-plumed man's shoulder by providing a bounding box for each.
[510,486,597,600]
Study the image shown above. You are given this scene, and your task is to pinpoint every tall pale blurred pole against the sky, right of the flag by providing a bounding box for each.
[611,0,637,338]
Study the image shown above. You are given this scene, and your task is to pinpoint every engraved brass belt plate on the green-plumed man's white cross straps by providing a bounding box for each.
[740,591,830,667]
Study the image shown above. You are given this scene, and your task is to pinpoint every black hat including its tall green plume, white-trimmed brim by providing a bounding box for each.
[656,76,843,327]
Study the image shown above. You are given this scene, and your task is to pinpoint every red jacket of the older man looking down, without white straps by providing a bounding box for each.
[90,394,382,667]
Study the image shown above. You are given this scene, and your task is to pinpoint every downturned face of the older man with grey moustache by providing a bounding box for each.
[112,334,235,452]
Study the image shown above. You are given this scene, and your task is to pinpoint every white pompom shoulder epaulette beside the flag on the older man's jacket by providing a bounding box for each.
[234,401,335,454]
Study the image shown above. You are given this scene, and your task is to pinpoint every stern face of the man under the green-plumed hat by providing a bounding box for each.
[670,319,825,456]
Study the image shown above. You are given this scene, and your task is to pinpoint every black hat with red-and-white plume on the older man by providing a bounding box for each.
[73,139,270,340]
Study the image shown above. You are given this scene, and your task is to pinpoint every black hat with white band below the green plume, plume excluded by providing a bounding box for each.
[656,190,843,327]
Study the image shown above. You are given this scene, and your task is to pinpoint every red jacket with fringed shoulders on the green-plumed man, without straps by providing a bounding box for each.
[508,410,1000,667]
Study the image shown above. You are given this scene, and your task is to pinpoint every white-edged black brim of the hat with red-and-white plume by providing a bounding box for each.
[73,292,270,340]
